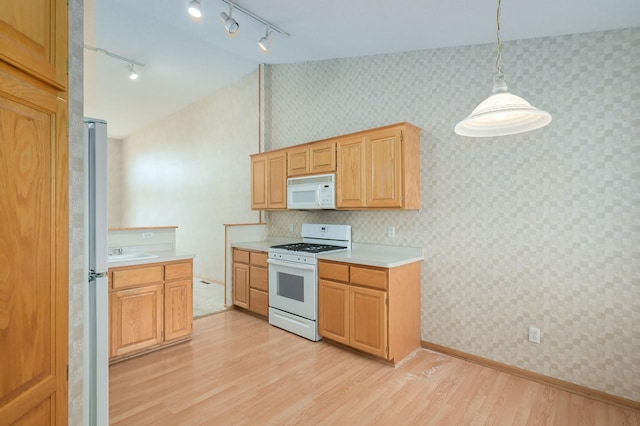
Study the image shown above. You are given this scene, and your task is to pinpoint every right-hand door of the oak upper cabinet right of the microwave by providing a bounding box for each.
[365,129,402,208]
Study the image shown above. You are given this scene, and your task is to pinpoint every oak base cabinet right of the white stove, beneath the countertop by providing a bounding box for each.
[318,260,421,364]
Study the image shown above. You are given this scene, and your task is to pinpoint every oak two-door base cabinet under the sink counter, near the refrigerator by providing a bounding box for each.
[109,259,193,362]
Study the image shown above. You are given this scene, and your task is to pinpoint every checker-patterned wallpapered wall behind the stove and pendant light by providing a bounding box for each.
[264,28,640,400]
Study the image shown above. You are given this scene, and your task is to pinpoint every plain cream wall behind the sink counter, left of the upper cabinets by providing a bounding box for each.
[120,71,259,282]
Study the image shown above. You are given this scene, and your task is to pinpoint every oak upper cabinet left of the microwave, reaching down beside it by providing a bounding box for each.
[251,151,287,210]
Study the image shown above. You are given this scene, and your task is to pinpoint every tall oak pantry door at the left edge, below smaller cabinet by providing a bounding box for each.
[0,65,69,424]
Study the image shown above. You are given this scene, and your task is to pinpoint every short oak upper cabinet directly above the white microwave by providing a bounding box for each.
[287,141,336,177]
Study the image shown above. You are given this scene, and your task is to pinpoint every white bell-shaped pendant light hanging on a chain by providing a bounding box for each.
[455,0,551,137]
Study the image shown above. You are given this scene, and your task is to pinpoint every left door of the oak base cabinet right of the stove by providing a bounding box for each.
[318,280,349,345]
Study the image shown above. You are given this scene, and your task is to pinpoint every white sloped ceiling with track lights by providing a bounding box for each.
[84,0,640,138]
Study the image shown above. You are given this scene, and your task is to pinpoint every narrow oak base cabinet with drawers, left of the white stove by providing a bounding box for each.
[233,248,269,317]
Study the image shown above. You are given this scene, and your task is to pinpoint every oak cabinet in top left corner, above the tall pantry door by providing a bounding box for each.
[0,0,68,89]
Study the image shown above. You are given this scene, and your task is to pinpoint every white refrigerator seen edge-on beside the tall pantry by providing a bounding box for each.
[83,118,109,426]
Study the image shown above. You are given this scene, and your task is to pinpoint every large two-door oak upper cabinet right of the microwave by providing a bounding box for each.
[336,123,420,209]
